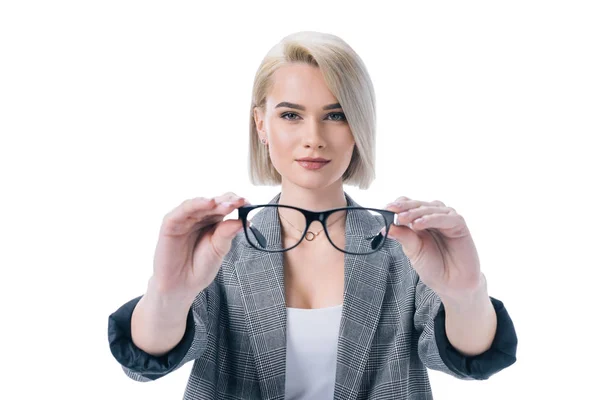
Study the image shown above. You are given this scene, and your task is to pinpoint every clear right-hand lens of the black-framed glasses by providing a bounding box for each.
[327,209,386,254]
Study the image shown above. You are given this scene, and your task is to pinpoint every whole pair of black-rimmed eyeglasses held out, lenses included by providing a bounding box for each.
[238,203,397,255]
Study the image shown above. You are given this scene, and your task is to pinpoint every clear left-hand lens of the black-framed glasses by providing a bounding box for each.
[245,206,306,250]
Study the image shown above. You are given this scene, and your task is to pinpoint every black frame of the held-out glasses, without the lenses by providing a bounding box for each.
[238,203,398,255]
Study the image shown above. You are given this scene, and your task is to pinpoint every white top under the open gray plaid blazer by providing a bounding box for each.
[285,304,342,400]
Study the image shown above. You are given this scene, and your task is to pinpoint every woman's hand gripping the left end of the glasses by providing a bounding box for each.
[151,192,249,300]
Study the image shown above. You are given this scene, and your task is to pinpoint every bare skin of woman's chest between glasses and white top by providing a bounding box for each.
[283,241,344,308]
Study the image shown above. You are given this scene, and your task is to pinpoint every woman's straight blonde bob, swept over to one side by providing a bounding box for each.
[249,31,376,189]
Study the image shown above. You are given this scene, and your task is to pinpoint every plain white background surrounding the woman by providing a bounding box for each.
[0,0,600,399]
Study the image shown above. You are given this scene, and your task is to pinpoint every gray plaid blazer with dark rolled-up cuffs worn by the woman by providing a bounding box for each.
[108,194,517,400]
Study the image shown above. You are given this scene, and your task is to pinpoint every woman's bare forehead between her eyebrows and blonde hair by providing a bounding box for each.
[267,63,337,110]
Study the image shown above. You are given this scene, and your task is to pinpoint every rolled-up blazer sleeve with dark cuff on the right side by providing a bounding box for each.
[414,280,517,380]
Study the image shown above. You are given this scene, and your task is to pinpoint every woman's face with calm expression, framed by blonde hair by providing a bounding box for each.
[254,63,354,189]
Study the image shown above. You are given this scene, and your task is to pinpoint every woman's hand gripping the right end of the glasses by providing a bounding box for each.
[386,196,485,300]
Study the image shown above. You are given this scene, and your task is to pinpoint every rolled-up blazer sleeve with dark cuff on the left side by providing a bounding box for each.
[108,280,219,382]
